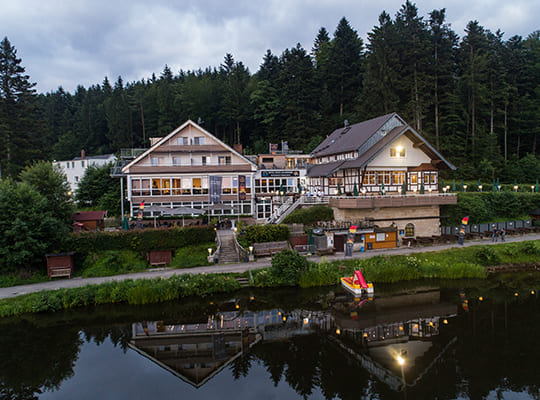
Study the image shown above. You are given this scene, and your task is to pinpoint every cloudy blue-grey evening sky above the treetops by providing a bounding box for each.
[4,0,540,93]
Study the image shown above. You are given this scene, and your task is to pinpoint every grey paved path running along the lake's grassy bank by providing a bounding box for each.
[0,233,540,299]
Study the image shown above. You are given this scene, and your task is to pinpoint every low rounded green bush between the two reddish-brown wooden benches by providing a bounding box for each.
[82,250,148,278]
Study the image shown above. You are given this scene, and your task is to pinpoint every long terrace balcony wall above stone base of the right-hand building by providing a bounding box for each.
[328,193,457,209]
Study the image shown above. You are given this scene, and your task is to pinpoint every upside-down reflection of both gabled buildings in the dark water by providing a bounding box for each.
[129,290,457,391]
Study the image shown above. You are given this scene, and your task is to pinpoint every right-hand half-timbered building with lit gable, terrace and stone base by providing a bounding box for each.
[307,113,457,244]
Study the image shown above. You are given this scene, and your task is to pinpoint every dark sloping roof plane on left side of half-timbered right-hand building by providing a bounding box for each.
[311,113,398,157]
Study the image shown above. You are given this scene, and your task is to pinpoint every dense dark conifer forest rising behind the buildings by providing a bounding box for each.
[0,1,540,181]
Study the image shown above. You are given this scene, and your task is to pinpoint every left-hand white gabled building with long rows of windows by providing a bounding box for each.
[122,121,257,216]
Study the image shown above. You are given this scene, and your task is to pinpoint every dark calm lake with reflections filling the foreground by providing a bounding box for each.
[0,274,540,400]
